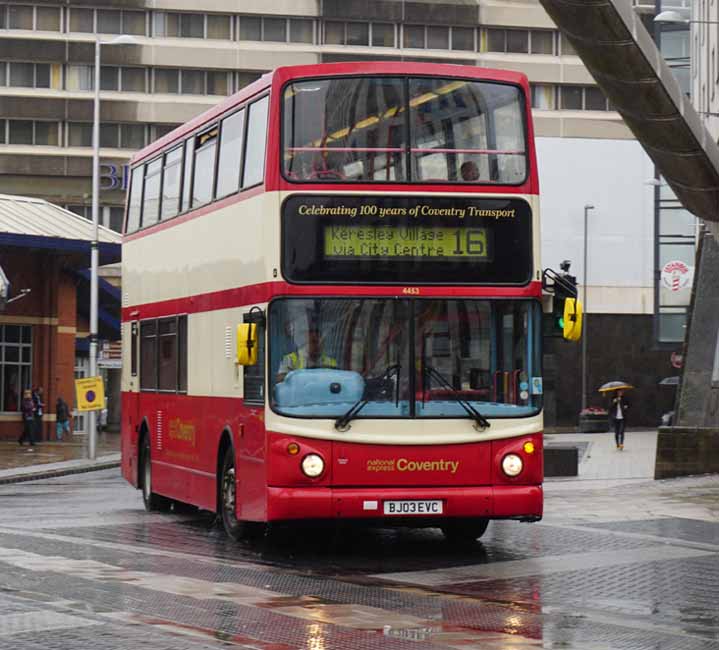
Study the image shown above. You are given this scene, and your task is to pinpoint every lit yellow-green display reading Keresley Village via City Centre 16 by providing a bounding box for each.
[324,225,489,262]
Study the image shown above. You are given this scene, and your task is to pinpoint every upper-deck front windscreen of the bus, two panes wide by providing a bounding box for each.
[282,77,527,185]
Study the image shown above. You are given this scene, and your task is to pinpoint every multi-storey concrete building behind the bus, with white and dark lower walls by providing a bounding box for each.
[0,0,669,423]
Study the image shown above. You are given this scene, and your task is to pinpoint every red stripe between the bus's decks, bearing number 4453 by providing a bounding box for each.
[122,282,542,322]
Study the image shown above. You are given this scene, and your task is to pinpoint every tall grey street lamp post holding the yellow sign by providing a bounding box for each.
[87,36,137,460]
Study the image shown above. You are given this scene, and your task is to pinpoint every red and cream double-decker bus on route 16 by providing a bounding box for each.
[122,62,543,538]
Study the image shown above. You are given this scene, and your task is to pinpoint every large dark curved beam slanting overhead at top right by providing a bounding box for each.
[540,0,719,223]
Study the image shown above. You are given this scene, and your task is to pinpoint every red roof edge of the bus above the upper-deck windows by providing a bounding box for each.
[130,61,528,165]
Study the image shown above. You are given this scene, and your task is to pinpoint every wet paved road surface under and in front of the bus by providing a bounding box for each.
[0,468,719,650]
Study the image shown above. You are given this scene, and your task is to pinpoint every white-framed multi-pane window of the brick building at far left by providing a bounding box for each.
[0,325,32,413]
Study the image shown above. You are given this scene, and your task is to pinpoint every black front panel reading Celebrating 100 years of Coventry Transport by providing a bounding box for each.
[282,195,532,285]
